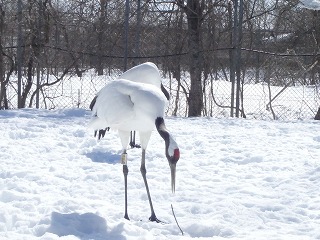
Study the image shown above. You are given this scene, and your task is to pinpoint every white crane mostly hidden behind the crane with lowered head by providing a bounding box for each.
[90,62,170,148]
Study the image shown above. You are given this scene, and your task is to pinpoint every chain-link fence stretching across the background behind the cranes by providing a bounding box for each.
[0,0,320,120]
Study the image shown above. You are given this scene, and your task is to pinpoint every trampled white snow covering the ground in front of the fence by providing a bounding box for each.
[0,109,320,240]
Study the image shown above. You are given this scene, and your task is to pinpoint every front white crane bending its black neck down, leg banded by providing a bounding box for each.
[90,63,180,222]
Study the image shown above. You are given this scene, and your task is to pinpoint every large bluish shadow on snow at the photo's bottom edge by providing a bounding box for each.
[47,212,125,240]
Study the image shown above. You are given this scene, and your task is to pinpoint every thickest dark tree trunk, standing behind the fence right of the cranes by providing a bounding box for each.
[186,0,203,117]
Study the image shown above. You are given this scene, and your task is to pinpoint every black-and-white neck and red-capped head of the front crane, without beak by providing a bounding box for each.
[155,117,180,164]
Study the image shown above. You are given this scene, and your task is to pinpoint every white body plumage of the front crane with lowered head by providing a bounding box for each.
[91,79,167,139]
